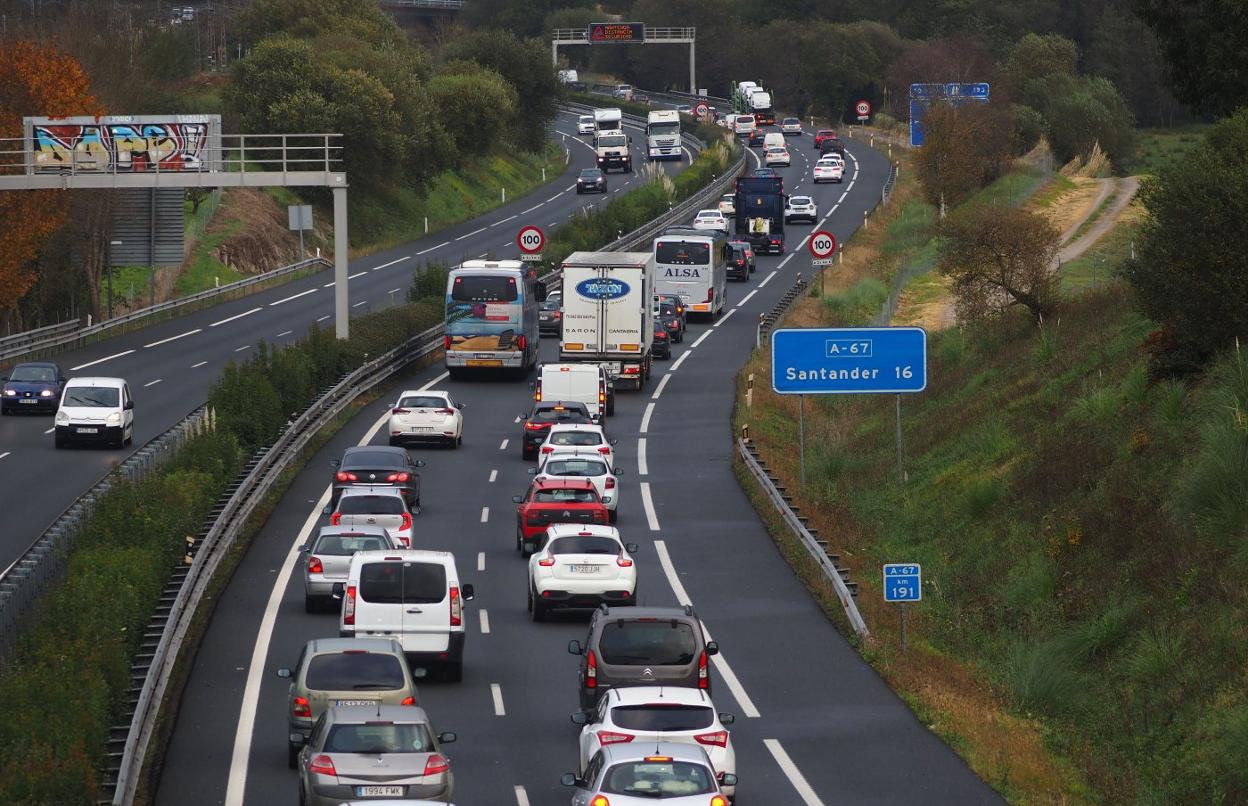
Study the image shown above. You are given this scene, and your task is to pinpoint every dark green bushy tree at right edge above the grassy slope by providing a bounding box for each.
[1123,110,1248,359]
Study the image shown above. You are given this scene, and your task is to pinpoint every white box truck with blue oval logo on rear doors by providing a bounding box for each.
[559,252,655,389]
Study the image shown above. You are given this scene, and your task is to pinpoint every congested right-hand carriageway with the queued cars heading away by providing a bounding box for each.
[156,129,1001,806]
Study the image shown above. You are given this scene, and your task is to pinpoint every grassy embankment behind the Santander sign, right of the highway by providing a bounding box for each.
[738,145,1248,804]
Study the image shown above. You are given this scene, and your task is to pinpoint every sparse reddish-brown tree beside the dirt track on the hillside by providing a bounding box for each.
[937,205,1060,322]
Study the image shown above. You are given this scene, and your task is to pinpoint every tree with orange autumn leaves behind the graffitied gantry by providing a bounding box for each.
[0,41,104,318]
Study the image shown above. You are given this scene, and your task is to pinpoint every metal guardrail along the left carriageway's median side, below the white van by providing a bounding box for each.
[0,407,205,660]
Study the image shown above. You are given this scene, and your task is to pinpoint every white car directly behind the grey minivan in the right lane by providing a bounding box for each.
[572,686,736,797]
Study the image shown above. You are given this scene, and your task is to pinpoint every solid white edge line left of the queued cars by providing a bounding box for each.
[225,372,449,806]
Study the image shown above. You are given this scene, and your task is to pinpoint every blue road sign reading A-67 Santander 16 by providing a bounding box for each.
[771,327,927,394]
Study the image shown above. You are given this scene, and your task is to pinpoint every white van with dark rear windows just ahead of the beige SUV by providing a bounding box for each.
[336,550,473,682]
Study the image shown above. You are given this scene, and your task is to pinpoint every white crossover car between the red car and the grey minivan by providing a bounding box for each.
[528,523,636,621]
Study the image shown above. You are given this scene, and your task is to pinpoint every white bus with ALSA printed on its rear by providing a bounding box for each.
[654,227,728,318]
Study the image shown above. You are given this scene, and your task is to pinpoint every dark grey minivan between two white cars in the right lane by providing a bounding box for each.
[568,604,719,711]
